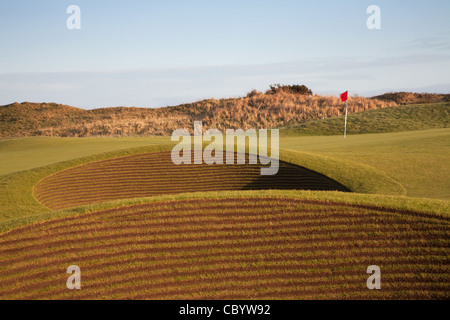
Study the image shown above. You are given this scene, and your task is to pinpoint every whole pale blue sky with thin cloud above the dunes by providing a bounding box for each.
[0,0,450,109]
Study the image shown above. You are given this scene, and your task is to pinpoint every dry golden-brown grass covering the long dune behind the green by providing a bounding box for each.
[0,92,395,137]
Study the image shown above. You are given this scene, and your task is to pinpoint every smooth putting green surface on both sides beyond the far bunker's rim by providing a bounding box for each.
[0,129,450,199]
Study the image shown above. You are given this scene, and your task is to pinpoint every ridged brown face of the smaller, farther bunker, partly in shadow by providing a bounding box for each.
[34,151,349,209]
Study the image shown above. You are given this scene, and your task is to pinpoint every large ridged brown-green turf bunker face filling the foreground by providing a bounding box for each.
[0,196,450,299]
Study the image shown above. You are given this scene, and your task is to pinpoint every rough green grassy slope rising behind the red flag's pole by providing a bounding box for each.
[281,102,450,136]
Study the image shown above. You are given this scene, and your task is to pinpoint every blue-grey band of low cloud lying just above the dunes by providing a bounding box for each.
[0,54,450,108]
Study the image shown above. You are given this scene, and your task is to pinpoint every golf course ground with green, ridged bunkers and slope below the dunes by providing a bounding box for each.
[0,103,450,299]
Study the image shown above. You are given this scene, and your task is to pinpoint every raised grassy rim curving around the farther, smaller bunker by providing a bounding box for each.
[0,145,404,226]
